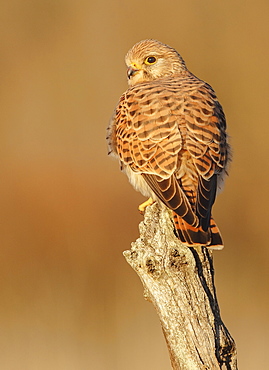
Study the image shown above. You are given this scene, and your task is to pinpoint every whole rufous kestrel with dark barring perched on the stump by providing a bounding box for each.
[107,40,230,249]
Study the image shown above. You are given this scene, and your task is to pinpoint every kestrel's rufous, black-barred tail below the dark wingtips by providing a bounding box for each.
[173,212,223,250]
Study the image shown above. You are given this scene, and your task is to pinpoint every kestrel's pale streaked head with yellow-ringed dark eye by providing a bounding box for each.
[125,39,187,86]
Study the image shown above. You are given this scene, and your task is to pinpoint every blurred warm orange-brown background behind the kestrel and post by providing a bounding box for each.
[0,0,269,370]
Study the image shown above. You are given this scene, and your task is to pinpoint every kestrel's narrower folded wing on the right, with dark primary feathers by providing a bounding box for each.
[184,84,229,230]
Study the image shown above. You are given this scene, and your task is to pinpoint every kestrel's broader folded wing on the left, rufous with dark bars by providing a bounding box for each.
[114,79,198,225]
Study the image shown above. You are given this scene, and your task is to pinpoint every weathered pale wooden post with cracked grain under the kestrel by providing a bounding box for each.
[124,203,237,370]
